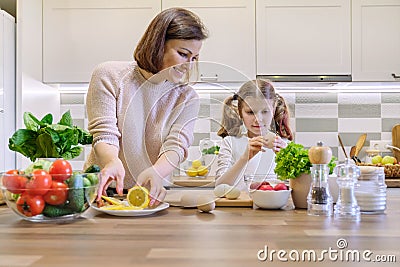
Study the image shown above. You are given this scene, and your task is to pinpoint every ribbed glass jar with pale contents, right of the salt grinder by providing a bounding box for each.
[355,166,387,214]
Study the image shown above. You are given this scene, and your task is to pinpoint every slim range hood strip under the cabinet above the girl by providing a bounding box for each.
[257,75,351,82]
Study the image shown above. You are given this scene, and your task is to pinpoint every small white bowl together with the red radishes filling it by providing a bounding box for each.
[244,174,292,209]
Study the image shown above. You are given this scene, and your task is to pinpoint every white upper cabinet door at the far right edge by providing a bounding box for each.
[352,0,400,81]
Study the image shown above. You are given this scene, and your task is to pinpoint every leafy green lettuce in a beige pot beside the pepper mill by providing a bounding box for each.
[274,142,336,208]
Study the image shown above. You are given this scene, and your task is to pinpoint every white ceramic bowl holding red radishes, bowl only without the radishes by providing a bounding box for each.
[250,189,292,209]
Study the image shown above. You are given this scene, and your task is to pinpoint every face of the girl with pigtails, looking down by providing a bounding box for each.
[241,97,274,138]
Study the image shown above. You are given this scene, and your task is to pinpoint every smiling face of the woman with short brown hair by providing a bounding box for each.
[162,39,203,83]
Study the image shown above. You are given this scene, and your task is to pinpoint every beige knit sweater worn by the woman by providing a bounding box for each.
[85,62,199,188]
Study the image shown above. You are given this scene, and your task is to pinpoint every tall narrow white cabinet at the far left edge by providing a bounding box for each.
[0,10,16,172]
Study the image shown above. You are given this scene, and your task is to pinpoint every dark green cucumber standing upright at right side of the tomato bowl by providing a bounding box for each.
[68,173,85,212]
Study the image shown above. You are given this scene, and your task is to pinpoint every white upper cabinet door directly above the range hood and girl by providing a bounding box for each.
[256,0,351,75]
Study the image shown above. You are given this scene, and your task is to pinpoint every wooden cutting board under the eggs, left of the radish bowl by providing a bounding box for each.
[164,190,253,207]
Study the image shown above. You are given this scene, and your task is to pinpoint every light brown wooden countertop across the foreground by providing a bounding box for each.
[0,188,400,267]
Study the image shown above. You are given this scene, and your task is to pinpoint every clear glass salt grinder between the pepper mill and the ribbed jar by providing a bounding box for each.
[334,158,361,222]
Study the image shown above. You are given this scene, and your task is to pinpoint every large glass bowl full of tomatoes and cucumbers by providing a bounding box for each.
[0,170,99,222]
